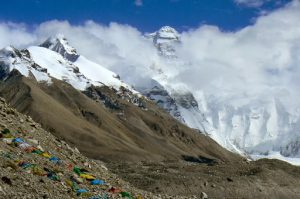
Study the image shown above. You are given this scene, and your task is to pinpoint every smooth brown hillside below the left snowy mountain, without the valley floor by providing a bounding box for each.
[0,71,240,161]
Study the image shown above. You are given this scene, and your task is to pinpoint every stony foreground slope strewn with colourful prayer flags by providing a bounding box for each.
[0,98,178,199]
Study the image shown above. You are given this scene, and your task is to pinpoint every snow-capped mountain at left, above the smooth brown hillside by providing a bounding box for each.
[0,34,137,94]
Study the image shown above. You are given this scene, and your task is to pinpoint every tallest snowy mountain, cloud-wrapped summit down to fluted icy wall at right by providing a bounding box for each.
[139,26,300,162]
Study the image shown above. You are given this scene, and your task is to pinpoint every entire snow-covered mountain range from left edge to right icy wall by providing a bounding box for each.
[0,26,300,164]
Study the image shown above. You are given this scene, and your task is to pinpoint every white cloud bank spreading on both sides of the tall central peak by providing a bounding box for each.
[0,0,300,109]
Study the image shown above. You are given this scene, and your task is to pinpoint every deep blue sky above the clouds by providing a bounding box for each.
[0,0,290,32]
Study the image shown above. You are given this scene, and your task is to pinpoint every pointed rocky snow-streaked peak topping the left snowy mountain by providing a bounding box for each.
[40,34,79,62]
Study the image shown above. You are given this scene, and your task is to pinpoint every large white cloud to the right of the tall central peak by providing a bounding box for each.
[177,1,300,107]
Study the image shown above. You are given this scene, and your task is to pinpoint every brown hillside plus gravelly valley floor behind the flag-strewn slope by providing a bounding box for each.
[0,72,300,198]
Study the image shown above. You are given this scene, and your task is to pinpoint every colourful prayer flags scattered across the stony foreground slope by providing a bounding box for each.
[0,129,138,199]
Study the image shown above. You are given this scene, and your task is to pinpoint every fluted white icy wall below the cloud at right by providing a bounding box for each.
[196,95,299,158]
